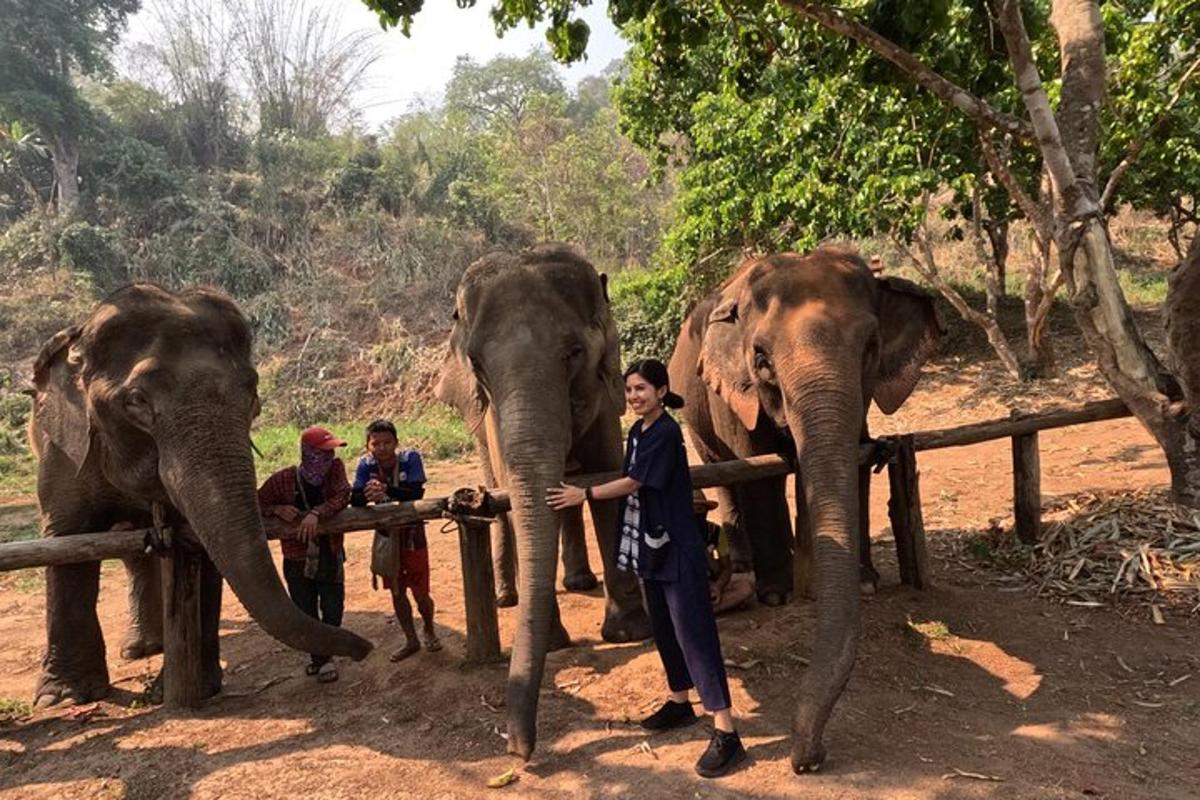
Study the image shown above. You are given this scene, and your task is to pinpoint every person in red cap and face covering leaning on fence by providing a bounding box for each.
[258,426,350,684]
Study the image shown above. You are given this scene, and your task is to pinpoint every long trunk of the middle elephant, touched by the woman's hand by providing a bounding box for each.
[496,380,570,759]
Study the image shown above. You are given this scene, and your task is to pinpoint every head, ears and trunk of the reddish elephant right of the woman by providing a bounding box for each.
[692,248,942,770]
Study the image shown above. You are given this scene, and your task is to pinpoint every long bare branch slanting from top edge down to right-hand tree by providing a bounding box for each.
[779,0,1034,140]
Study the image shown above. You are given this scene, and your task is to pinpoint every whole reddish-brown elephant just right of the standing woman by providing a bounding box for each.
[670,247,943,772]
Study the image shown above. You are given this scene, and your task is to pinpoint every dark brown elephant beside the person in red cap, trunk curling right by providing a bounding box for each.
[29,284,371,706]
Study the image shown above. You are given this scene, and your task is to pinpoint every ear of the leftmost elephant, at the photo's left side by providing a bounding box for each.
[34,326,92,470]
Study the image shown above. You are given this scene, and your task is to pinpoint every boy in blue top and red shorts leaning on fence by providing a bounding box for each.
[350,420,442,661]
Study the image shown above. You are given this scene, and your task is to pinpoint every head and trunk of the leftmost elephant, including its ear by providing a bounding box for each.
[31,284,371,658]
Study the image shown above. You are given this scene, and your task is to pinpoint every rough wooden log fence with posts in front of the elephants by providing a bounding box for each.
[0,399,1130,708]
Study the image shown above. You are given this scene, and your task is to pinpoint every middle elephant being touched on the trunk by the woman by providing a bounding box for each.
[437,243,650,759]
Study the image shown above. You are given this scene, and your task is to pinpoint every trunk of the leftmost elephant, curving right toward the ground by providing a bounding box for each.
[158,419,372,661]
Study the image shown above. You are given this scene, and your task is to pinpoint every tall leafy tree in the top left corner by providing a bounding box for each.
[0,0,140,212]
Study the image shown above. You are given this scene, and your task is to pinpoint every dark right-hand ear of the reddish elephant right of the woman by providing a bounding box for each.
[872,277,946,414]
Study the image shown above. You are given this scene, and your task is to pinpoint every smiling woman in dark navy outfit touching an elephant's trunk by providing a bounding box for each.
[546,359,745,777]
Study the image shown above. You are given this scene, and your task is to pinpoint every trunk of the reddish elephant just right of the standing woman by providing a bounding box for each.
[785,376,862,772]
